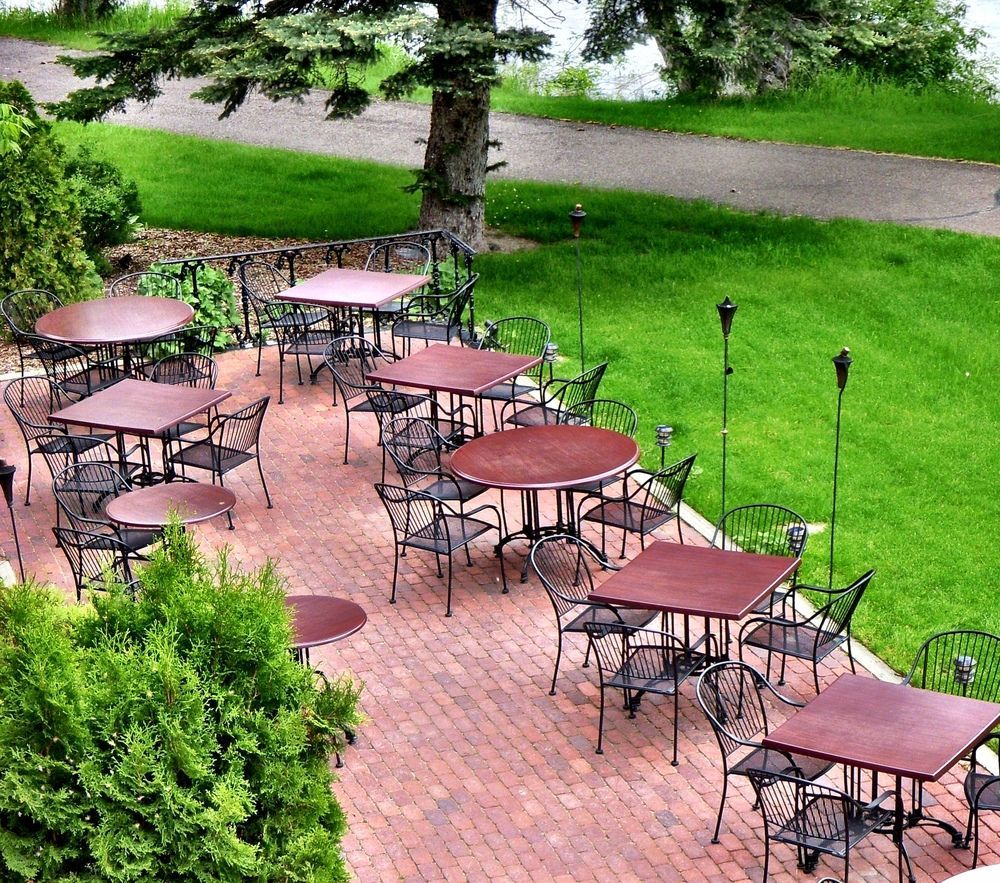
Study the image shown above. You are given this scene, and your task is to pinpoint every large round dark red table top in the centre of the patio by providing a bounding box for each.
[451,424,639,491]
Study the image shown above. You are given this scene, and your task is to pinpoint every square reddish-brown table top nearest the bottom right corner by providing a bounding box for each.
[764,675,1000,781]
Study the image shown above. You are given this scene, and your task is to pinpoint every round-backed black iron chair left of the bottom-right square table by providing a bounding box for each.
[697,662,833,843]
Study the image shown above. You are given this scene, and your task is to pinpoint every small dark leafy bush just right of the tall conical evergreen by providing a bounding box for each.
[66,147,141,265]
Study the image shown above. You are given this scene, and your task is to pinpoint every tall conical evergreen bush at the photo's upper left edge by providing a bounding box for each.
[0,82,101,310]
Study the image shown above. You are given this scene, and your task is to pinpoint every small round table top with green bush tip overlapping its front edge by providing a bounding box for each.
[104,481,236,528]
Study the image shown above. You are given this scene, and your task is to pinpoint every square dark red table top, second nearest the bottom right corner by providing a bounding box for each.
[589,542,801,620]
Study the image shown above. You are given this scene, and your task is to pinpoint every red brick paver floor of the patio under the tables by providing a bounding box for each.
[0,349,1000,883]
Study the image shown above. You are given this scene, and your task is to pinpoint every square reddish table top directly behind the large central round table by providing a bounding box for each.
[368,343,542,396]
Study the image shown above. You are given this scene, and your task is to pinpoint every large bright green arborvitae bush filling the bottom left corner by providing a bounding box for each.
[0,526,359,883]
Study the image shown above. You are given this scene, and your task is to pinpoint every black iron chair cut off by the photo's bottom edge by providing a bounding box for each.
[747,766,909,883]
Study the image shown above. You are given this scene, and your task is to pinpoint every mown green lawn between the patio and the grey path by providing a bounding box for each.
[52,119,1000,668]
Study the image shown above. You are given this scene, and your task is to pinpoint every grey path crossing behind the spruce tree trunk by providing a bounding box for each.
[0,38,1000,236]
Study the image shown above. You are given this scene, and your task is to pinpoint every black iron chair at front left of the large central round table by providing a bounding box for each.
[375,484,507,616]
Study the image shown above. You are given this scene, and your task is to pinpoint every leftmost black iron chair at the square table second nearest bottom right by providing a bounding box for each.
[528,534,660,696]
